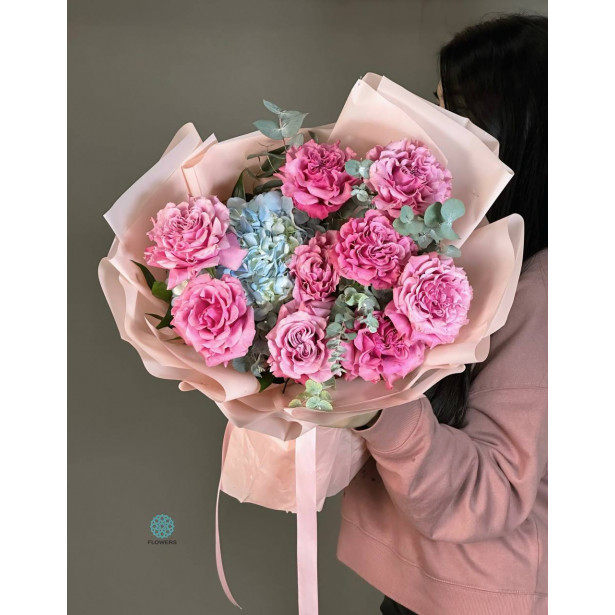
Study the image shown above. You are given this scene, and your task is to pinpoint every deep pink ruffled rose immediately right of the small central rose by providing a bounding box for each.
[331,209,418,289]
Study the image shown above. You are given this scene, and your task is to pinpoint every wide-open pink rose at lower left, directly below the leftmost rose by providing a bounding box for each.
[171,273,255,367]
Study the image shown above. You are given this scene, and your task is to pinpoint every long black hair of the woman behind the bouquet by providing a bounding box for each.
[426,15,548,427]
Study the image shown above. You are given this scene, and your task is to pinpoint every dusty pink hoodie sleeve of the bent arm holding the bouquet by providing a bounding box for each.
[358,253,547,543]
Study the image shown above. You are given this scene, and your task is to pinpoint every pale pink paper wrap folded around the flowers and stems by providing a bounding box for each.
[99,74,523,510]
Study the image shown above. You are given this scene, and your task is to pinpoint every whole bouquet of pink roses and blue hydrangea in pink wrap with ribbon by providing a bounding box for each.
[100,74,523,613]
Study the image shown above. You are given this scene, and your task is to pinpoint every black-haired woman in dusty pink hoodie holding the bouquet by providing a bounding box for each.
[338,16,547,615]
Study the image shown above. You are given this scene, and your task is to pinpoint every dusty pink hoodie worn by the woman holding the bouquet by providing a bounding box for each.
[338,250,547,615]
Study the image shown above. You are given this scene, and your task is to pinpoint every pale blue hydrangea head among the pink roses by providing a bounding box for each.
[227,190,307,322]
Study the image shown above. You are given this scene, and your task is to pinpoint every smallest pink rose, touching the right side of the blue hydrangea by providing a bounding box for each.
[288,231,340,302]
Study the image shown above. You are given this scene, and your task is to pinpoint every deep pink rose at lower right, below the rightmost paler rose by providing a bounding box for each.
[342,311,425,389]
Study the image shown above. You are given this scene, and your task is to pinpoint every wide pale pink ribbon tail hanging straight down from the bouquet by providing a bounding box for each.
[295,429,318,615]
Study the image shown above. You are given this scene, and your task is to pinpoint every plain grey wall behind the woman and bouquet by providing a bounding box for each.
[68,0,547,615]
